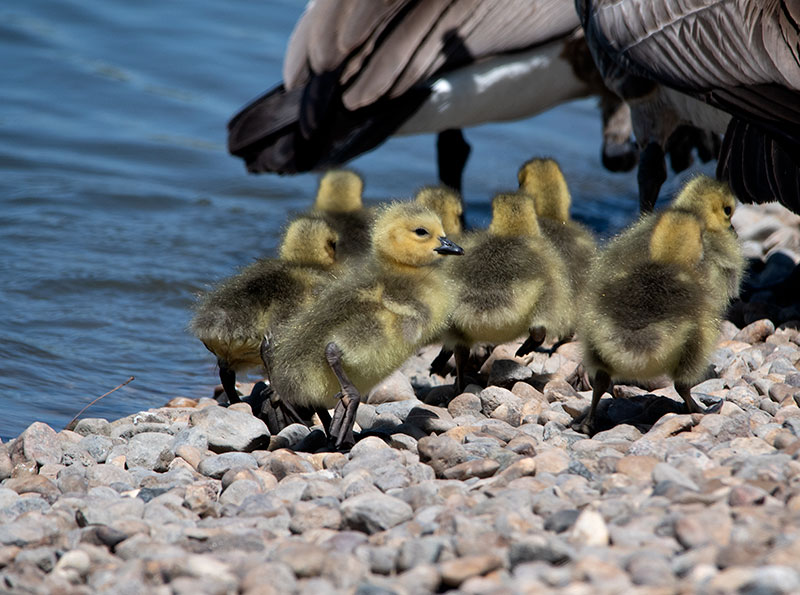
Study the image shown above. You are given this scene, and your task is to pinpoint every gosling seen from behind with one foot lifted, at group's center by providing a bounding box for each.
[444,192,570,391]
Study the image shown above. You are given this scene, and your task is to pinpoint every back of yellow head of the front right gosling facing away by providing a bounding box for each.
[650,210,703,266]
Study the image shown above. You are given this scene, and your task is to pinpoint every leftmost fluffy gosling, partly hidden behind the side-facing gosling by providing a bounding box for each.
[189,216,338,403]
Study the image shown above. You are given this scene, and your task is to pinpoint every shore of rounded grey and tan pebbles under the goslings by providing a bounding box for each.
[0,207,800,595]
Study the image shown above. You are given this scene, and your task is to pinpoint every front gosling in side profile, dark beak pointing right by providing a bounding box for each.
[271,202,463,448]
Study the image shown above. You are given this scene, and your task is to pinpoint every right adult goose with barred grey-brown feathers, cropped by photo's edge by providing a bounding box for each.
[576,0,800,213]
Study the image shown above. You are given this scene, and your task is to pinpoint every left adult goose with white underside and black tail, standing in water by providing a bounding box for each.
[228,0,637,190]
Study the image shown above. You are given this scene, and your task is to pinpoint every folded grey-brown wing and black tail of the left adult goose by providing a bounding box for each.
[228,0,579,173]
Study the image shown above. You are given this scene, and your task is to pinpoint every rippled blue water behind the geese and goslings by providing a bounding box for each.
[0,0,712,440]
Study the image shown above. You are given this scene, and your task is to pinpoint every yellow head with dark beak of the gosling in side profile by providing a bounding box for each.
[372,202,464,267]
